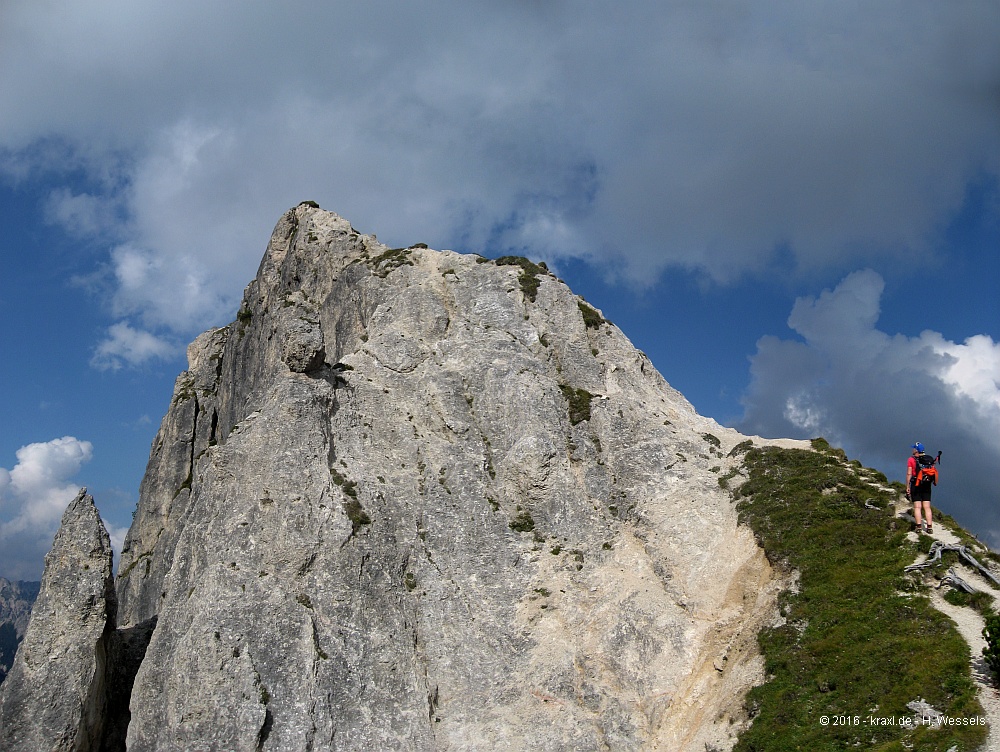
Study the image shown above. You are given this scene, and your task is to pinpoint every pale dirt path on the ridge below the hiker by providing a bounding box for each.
[897,503,1000,750]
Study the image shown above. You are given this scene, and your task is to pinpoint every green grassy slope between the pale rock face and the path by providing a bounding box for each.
[735,440,986,752]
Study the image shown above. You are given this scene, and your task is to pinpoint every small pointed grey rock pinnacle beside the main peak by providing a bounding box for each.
[0,489,116,752]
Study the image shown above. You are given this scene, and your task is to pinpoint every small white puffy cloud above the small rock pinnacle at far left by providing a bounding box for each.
[0,436,93,579]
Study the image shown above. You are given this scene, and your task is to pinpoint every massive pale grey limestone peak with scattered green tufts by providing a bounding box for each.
[107,204,796,751]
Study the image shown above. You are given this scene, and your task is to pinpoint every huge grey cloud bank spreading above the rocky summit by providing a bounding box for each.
[0,0,1000,333]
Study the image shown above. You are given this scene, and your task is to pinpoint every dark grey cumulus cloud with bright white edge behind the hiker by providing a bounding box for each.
[738,270,1000,547]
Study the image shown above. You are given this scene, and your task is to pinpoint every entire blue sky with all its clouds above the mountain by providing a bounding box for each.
[0,0,1000,579]
